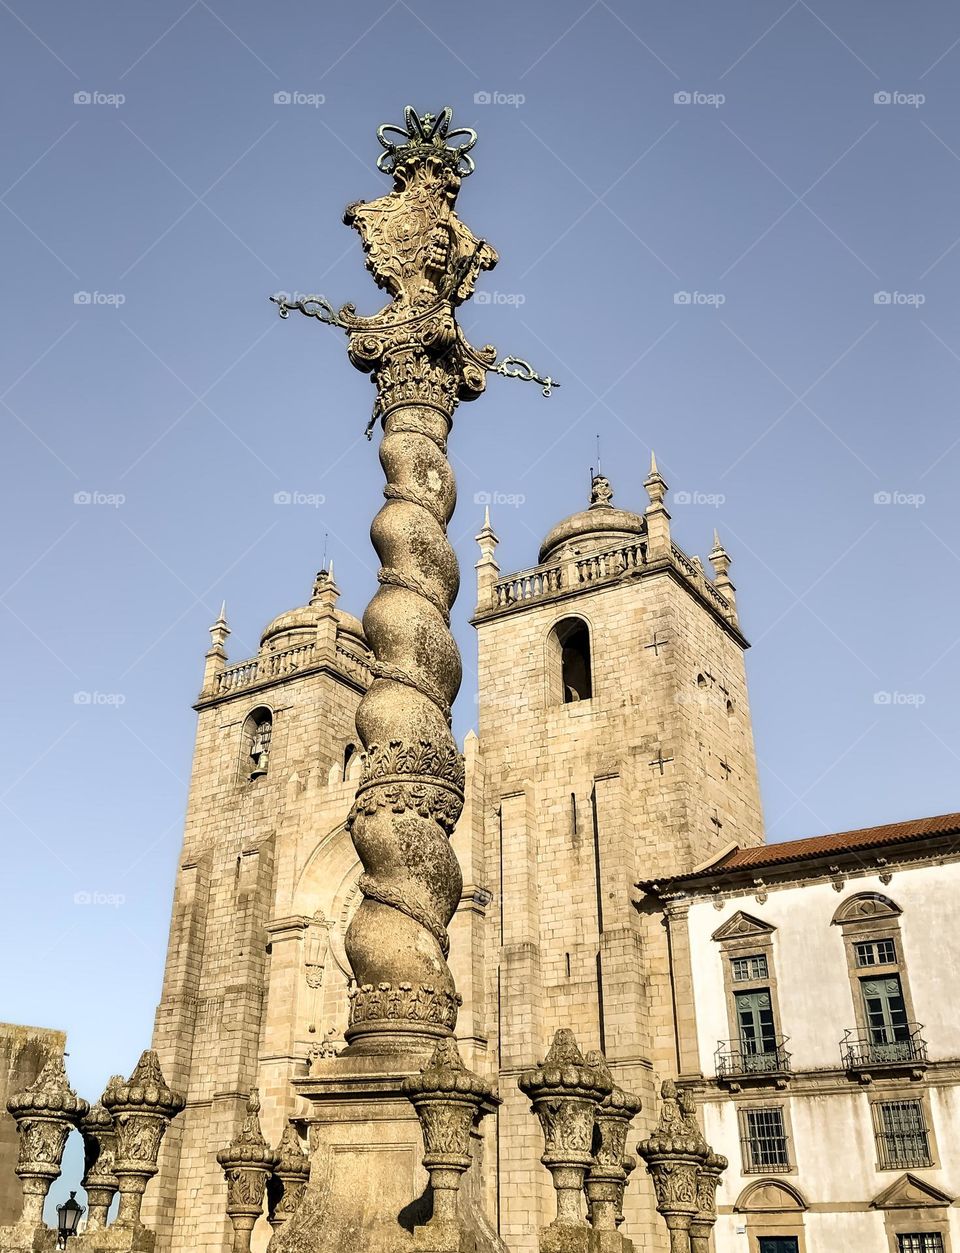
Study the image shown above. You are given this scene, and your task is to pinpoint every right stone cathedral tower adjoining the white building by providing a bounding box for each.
[474,459,763,1249]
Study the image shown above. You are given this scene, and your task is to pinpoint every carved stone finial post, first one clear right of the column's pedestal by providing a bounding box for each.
[518,1029,613,1253]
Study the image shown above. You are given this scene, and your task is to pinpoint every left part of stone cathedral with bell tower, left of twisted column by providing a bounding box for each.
[145,563,370,1253]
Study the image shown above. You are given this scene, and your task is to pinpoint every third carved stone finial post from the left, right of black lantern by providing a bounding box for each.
[100,1049,185,1228]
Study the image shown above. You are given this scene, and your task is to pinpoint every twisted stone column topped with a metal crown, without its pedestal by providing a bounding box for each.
[273,107,555,1054]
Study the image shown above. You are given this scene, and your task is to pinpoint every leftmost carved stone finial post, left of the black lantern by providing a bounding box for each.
[6,1053,90,1230]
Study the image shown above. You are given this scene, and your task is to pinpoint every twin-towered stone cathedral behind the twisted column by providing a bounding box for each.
[144,461,762,1253]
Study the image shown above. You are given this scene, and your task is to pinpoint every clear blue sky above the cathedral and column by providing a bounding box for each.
[0,0,960,1197]
